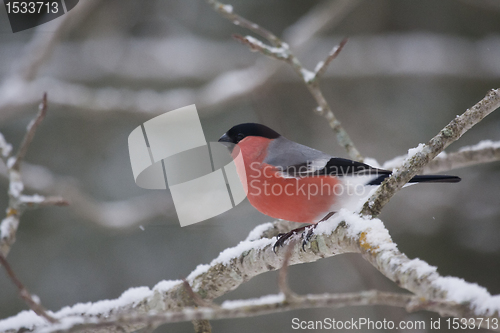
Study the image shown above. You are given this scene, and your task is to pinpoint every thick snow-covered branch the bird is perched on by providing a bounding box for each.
[0,210,500,332]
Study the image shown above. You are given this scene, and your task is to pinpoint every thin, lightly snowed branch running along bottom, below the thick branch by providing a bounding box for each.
[10,290,480,333]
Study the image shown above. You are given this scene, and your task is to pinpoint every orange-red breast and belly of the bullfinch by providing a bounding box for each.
[233,137,339,223]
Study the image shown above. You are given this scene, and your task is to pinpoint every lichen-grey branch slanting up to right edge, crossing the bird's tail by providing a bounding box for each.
[361,89,500,216]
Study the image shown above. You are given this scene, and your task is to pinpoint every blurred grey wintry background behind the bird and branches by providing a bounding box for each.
[0,0,500,332]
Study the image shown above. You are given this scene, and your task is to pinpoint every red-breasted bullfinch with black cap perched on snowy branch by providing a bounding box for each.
[219,123,460,245]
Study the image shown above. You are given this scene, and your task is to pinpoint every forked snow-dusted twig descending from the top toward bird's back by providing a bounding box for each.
[207,0,363,161]
